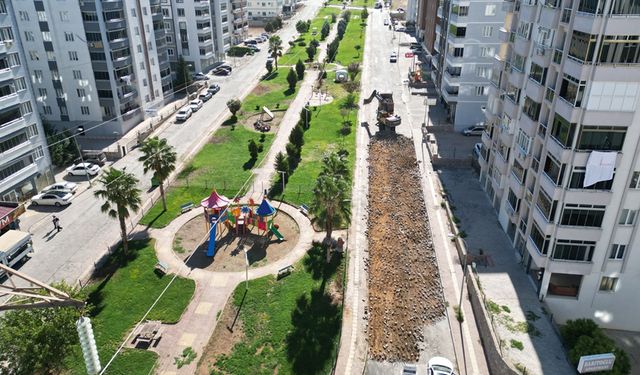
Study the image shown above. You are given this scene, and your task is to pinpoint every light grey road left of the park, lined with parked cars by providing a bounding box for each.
[15,0,322,283]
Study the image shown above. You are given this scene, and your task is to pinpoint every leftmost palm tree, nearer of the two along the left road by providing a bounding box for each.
[94,168,142,254]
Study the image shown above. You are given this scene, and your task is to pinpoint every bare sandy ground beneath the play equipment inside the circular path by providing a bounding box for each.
[174,212,300,272]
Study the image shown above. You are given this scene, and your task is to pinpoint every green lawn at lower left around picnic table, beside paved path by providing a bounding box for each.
[67,240,195,375]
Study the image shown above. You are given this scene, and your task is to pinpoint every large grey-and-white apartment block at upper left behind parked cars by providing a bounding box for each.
[13,0,172,142]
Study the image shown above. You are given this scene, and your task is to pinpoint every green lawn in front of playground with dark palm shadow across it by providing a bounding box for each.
[212,244,343,375]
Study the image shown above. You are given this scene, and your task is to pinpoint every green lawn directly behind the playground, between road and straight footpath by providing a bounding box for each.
[140,126,274,228]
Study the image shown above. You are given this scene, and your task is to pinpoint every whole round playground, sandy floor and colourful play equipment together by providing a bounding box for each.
[174,190,300,272]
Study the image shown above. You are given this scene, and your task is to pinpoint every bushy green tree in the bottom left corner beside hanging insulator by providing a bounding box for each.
[0,282,84,374]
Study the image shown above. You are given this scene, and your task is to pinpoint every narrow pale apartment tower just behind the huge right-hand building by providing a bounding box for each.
[431,0,505,130]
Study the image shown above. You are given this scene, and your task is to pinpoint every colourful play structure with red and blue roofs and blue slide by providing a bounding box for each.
[200,189,284,257]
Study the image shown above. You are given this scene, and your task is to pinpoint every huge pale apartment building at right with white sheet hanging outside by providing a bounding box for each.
[479,0,640,331]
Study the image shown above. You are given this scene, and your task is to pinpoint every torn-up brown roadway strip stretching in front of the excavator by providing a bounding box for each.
[366,135,445,362]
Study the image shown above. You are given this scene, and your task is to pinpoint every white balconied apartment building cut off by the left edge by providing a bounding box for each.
[0,0,53,202]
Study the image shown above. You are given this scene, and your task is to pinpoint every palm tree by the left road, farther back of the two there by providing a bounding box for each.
[138,137,177,211]
